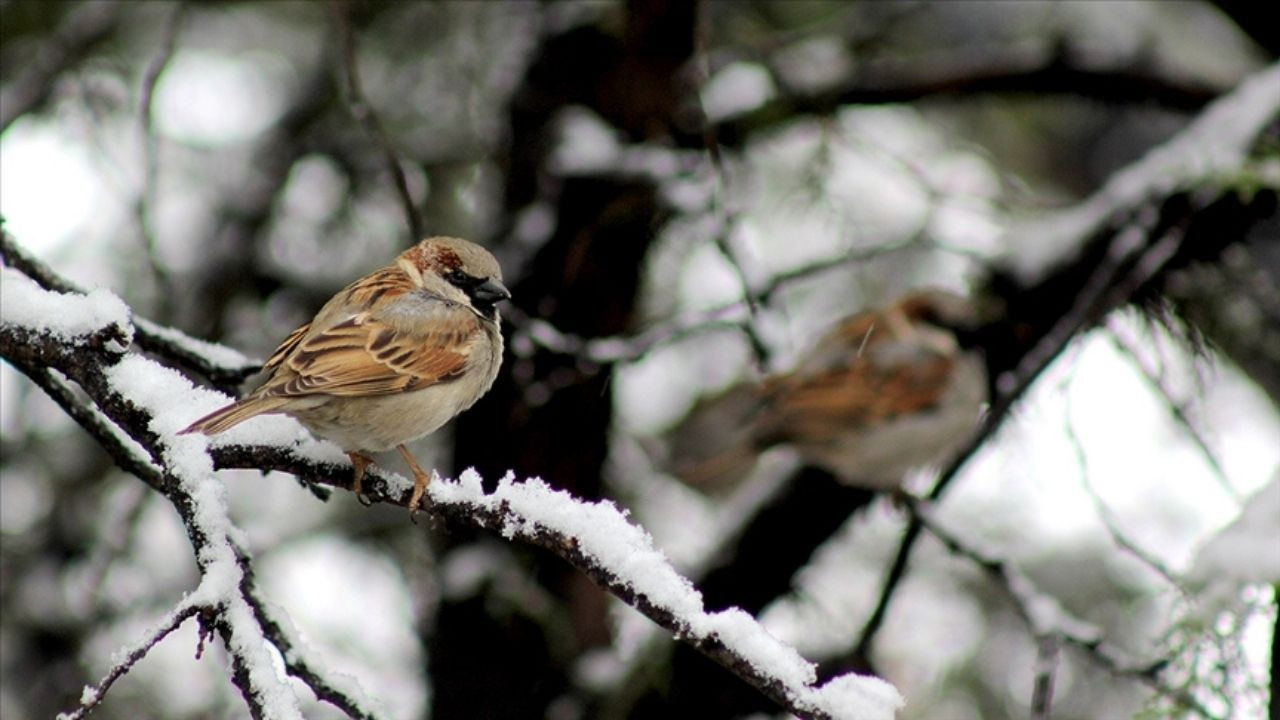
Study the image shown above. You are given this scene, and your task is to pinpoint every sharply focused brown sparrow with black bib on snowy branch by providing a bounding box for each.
[182,237,511,510]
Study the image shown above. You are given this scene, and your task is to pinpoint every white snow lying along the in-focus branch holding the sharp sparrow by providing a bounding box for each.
[0,238,902,720]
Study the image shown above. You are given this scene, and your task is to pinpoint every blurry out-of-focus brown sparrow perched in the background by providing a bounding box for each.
[672,290,987,489]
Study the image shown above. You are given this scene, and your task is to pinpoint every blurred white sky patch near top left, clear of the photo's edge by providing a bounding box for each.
[152,50,287,147]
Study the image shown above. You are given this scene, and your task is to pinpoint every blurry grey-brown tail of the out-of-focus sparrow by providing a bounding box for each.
[668,383,762,493]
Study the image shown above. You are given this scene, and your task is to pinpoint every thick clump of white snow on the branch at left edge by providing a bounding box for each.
[0,268,133,342]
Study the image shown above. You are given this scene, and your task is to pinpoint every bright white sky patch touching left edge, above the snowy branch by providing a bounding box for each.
[0,118,110,256]
